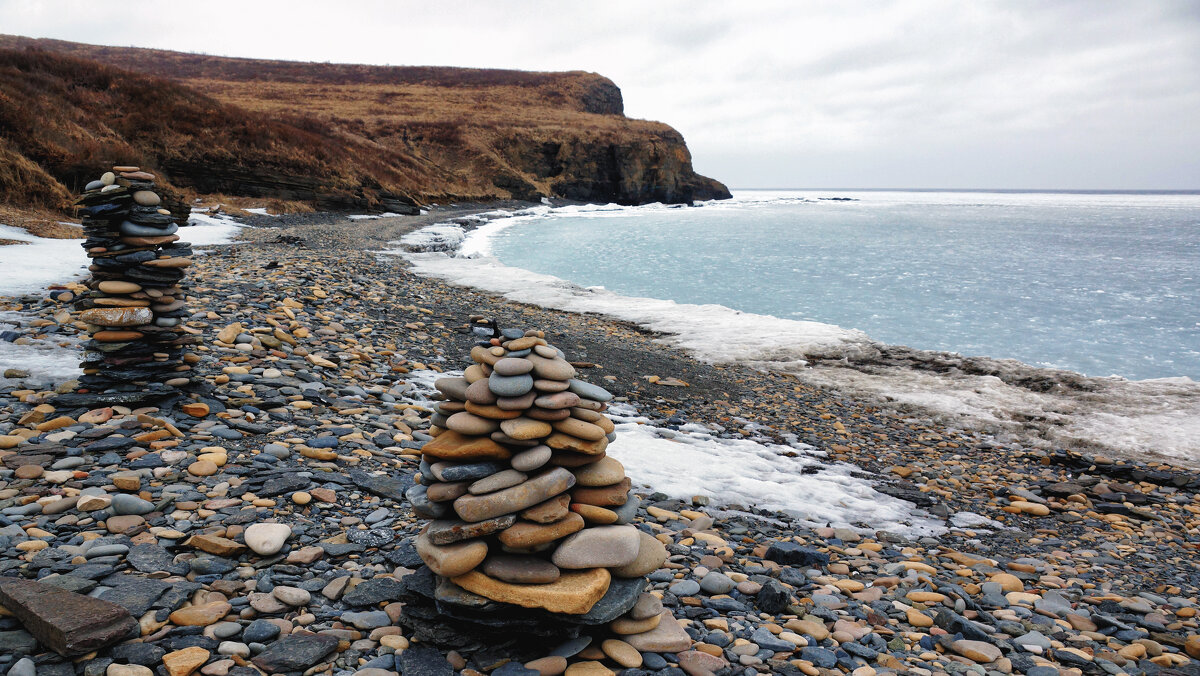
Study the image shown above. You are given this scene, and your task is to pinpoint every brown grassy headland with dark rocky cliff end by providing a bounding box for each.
[0,36,728,210]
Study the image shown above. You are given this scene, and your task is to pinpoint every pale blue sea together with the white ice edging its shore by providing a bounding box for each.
[397,190,1200,465]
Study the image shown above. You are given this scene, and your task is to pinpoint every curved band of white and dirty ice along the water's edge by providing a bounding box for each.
[390,205,1200,467]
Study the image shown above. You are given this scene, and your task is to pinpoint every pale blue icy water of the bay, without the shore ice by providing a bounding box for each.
[491,191,1200,379]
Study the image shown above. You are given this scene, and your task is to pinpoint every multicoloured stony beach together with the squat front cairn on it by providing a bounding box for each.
[0,211,1200,676]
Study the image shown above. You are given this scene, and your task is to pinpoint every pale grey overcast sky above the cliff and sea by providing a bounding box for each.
[0,0,1200,189]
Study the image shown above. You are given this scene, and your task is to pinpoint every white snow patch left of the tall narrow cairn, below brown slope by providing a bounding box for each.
[0,225,88,295]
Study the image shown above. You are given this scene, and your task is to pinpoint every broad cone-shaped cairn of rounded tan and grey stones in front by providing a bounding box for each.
[407,325,667,615]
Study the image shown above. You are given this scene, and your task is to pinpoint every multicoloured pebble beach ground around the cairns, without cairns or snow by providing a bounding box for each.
[0,205,1200,676]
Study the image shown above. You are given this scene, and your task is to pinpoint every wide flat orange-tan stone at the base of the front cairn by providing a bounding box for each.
[452,568,609,614]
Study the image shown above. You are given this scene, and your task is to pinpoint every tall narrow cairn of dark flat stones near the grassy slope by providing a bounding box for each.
[77,166,197,402]
